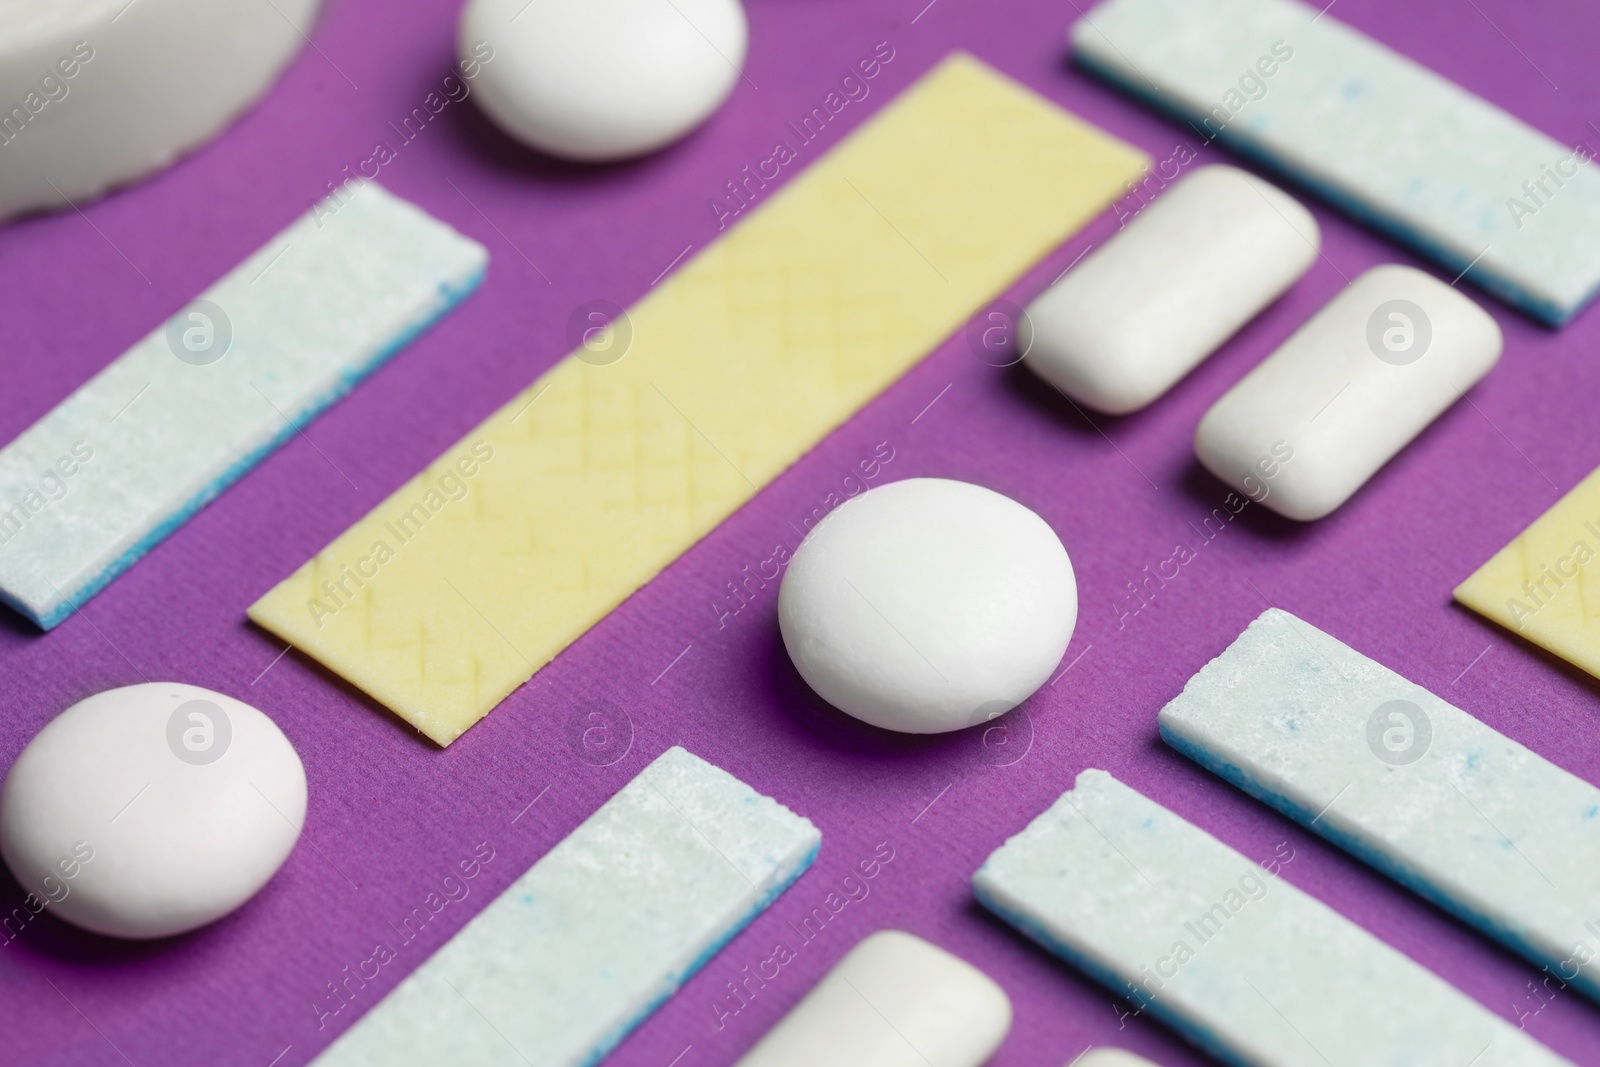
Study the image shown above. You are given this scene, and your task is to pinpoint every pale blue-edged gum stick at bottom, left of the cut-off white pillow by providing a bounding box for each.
[315,747,822,1067]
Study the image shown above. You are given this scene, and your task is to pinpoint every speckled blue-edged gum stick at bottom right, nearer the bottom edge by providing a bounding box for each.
[973,769,1566,1067]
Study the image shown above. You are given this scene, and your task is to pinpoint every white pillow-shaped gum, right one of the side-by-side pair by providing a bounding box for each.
[1195,264,1501,520]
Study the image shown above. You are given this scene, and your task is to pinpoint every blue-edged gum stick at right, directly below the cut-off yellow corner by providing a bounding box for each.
[1160,609,1600,1000]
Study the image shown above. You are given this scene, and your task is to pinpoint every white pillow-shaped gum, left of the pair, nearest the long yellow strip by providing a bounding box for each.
[1024,166,1322,414]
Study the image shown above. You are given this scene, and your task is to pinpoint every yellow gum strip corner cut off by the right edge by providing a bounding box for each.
[1456,470,1600,677]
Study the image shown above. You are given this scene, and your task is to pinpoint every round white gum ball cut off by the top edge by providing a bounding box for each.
[458,0,749,163]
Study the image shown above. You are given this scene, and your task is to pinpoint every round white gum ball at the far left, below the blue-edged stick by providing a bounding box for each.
[0,681,306,937]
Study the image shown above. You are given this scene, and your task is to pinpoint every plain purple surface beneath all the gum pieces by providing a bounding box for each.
[0,0,1600,1067]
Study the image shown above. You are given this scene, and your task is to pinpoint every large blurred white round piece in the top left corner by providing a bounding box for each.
[0,0,317,219]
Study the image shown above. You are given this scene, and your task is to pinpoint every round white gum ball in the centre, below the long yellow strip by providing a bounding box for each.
[778,478,1078,734]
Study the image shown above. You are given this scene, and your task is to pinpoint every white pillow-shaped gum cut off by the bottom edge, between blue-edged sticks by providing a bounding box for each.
[736,929,1011,1067]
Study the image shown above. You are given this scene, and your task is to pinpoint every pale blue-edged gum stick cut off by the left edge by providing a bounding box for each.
[0,182,488,630]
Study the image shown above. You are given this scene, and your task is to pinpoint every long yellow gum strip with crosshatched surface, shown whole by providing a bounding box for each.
[250,53,1146,745]
